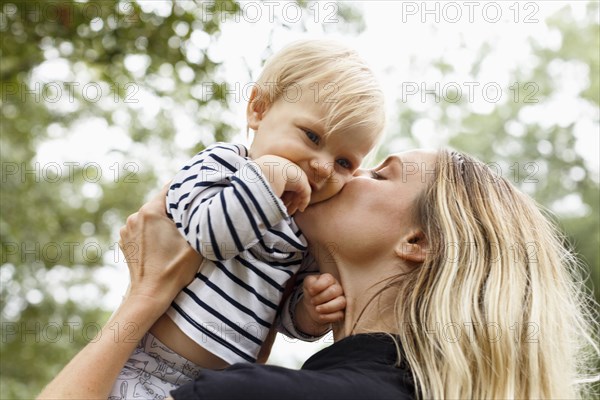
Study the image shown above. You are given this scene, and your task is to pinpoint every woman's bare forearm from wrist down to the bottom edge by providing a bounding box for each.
[38,297,168,399]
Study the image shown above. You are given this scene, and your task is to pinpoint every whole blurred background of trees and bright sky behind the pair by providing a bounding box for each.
[0,0,600,399]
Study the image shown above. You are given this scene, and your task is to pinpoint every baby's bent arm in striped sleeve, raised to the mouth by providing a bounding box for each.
[167,144,310,261]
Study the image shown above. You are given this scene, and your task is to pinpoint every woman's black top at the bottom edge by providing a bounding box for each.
[171,334,415,400]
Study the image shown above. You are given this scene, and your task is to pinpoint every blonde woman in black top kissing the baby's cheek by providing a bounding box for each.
[42,150,599,399]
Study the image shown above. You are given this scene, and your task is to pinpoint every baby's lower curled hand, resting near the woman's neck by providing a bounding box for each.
[300,273,346,336]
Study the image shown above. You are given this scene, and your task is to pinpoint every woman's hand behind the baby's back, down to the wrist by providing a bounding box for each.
[119,185,202,312]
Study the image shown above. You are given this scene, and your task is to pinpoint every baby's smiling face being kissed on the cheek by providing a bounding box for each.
[249,91,377,204]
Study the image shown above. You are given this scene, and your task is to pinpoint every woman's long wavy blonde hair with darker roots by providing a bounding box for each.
[387,150,599,399]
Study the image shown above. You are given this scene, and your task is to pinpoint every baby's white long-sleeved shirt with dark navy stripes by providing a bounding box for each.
[166,143,308,364]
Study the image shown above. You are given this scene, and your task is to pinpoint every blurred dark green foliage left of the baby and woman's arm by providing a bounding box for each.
[0,0,361,399]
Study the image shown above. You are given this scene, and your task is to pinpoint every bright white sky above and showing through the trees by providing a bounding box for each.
[22,1,600,367]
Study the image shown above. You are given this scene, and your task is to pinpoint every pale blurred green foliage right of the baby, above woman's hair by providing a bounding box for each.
[392,2,600,300]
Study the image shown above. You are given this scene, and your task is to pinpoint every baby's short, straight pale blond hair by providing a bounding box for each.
[253,40,385,136]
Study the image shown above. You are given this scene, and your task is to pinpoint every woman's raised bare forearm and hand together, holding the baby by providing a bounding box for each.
[38,187,202,399]
